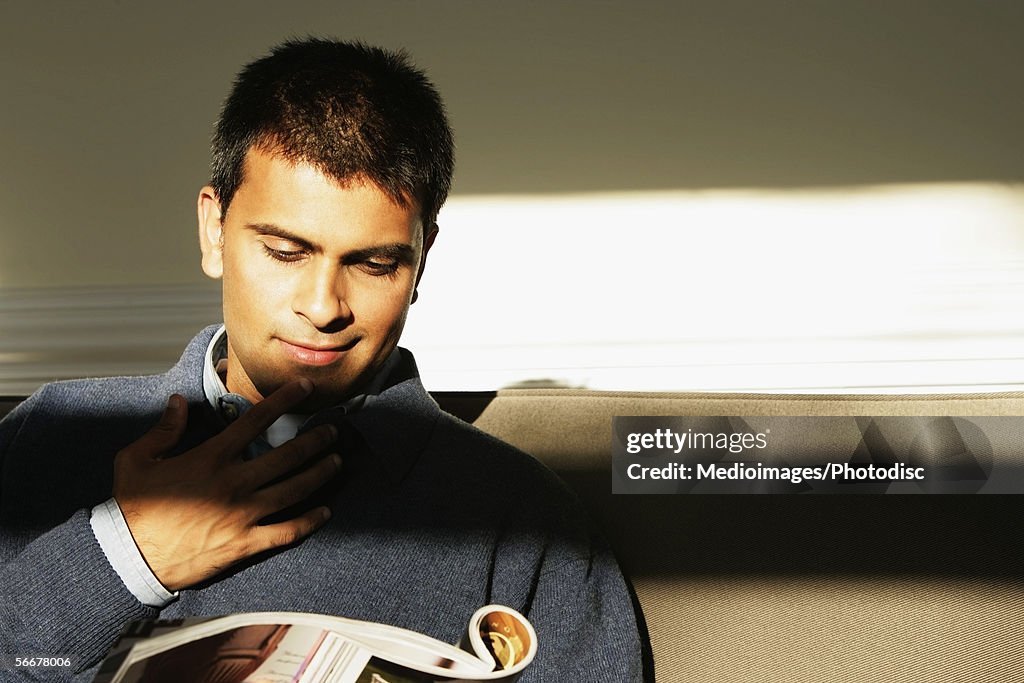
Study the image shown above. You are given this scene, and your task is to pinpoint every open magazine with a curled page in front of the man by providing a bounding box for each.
[93,605,537,683]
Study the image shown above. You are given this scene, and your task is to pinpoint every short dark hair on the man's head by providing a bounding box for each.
[210,38,454,227]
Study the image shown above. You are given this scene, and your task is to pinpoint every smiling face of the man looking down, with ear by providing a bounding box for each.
[199,148,435,411]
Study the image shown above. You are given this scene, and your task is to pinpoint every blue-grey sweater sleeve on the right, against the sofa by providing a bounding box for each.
[481,448,644,683]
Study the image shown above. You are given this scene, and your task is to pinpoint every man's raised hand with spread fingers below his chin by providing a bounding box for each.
[114,380,341,591]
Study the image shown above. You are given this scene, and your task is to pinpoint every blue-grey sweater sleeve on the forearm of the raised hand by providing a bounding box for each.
[0,394,158,681]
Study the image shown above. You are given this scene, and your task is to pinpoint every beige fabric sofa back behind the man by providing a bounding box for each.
[0,389,1024,683]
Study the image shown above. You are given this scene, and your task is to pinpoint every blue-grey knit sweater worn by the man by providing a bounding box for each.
[0,327,641,682]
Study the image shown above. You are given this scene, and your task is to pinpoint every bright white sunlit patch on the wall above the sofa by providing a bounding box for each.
[402,183,1024,392]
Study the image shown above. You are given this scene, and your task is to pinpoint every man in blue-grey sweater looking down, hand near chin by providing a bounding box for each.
[0,40,640,681]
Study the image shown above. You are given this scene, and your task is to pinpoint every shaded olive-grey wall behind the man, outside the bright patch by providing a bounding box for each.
[0,0,1024,389]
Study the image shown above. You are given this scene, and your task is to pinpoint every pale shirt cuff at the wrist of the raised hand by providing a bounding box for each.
[89,498,178,607]
